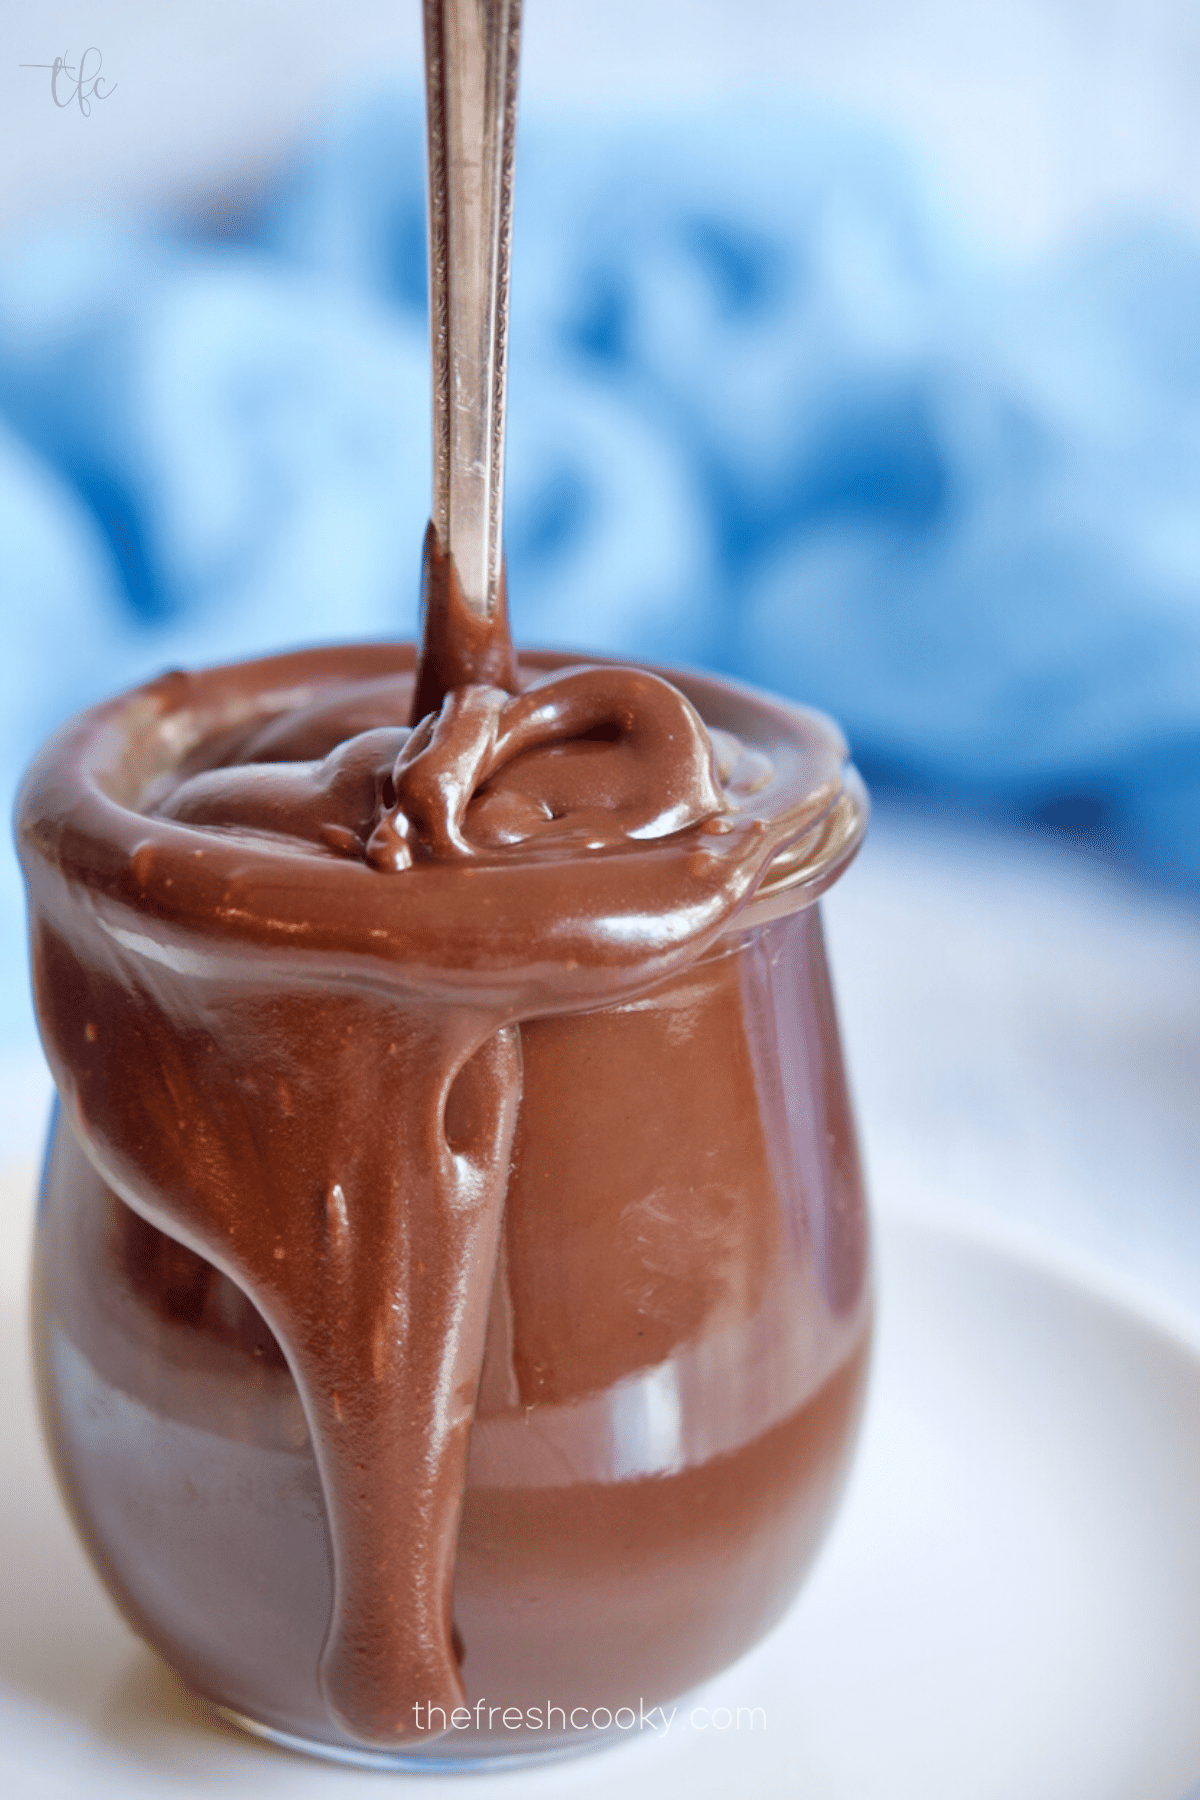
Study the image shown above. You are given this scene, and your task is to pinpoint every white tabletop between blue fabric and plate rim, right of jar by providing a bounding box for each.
[826,812,1200,1316]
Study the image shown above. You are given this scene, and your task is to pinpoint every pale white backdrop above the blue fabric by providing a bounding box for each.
[0,0,1200,247]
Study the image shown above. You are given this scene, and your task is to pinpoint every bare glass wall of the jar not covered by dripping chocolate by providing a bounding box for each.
[18,652,871,1768]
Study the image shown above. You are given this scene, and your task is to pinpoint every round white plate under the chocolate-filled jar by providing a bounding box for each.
[0,1180,1200,1800]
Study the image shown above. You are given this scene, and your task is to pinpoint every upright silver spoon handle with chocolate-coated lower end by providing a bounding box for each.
[412,0,520,724]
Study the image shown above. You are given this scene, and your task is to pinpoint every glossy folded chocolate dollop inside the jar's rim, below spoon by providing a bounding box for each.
[157,668,730,873]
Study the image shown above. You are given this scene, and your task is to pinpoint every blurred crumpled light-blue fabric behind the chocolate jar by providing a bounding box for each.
[0,92,1200,1048]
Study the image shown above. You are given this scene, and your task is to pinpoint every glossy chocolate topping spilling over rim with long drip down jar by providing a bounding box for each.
[20,650,862,1746]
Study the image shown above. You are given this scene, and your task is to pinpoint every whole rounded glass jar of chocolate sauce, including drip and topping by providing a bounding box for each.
[18,646,871,1768]
